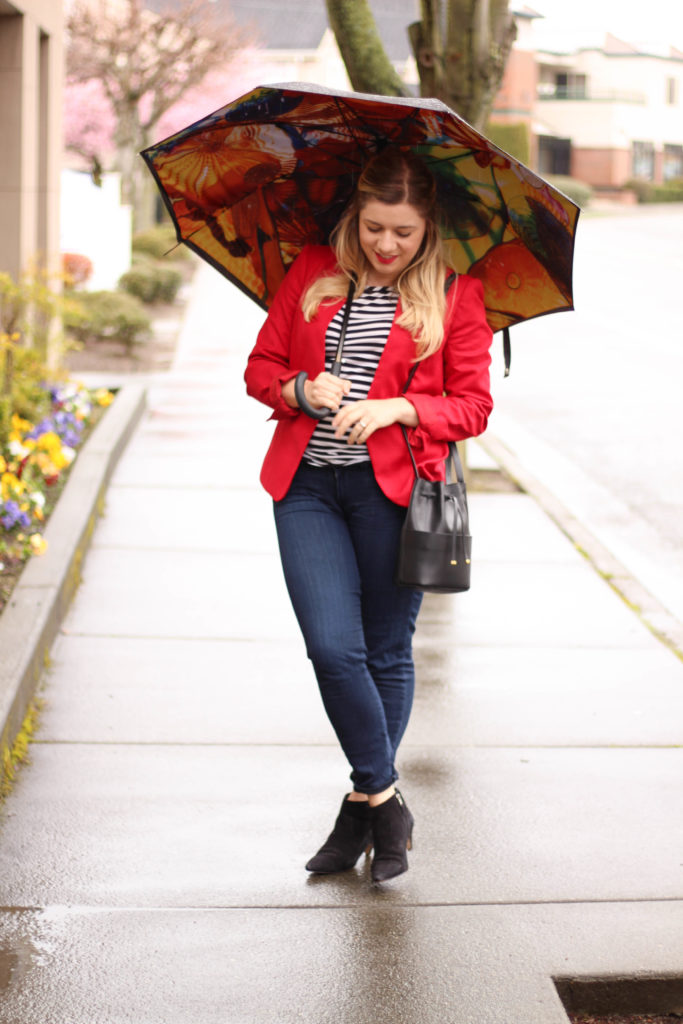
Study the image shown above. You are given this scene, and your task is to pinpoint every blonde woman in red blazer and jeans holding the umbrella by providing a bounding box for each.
[245,148,492,882]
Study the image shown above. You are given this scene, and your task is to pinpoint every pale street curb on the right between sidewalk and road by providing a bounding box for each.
[477,432,683,660]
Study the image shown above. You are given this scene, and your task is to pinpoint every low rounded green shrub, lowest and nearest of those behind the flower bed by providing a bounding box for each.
[66,292,152,348]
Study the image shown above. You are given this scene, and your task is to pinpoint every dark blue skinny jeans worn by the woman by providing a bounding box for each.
[274,462,422,794]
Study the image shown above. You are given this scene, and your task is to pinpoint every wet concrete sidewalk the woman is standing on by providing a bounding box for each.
[0,267,683,1024]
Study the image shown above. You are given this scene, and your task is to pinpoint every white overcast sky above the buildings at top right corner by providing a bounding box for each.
[525,0,683,50]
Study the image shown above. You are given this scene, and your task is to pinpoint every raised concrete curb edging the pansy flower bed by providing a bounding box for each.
[0,385,146,780]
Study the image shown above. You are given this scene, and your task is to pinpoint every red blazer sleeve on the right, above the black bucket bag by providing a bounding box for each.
[405,274,494,447]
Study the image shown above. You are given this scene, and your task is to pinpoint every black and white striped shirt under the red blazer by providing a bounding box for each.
[303,287,398,466]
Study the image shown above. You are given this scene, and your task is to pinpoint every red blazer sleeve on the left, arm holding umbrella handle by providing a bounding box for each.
[245,249,319,420]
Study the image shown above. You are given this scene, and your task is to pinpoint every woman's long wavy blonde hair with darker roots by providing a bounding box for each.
[301,146,445,361]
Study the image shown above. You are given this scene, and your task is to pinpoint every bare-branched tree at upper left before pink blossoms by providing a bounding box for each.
[67,0,242,228]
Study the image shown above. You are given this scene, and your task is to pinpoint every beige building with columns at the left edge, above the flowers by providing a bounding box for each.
[0,0,63,275]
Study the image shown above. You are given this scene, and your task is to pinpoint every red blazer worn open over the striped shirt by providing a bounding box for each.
[245,246,493,506]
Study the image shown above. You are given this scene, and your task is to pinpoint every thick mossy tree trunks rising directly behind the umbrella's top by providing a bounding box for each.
[327,0,516,129]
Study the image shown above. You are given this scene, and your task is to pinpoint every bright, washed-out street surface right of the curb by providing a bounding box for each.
[489,204,683,620]
